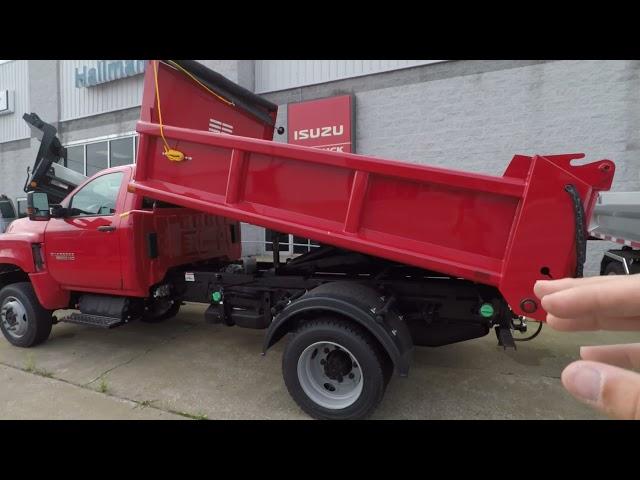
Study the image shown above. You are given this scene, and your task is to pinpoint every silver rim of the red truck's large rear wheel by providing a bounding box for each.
[298,342,364,410]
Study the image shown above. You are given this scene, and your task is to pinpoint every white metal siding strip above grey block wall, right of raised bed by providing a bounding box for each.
[255,60,445,93]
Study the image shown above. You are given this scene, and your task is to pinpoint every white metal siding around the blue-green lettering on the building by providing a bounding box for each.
[60,60,144,121]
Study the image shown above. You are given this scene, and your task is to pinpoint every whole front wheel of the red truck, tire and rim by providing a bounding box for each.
[0,282,53,347]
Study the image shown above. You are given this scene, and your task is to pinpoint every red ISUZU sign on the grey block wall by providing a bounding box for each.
[287,95,355,153]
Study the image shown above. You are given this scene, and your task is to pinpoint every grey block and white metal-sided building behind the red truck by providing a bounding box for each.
[0,60,640,274]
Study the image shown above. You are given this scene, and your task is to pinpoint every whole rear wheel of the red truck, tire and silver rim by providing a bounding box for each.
[282,318,389,420]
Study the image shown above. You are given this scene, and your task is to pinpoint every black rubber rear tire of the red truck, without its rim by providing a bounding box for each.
[282,318,392,420]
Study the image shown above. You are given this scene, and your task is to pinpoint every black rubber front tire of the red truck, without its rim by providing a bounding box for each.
[0,282,53,348]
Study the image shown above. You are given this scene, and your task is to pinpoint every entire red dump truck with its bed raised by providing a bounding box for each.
[0,60,615,419]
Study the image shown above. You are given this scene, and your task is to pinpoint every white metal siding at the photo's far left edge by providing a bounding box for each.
[0,60,31,143]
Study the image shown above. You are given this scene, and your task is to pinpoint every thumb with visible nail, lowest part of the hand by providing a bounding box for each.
[562,360,640,420]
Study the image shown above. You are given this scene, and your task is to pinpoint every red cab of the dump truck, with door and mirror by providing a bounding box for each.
[0,165,241,343]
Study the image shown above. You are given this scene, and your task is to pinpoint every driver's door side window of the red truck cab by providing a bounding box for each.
[69,172,124,217]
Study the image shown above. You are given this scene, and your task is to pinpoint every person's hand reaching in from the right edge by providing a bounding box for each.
[534,274,640,420]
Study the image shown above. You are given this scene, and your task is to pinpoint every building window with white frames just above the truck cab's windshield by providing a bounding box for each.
[66,135,138,177]
